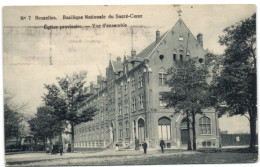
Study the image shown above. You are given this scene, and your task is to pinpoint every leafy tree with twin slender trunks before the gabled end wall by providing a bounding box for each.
[164,59,209,150]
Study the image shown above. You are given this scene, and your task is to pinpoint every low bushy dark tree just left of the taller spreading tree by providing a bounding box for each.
[28,106,59,147]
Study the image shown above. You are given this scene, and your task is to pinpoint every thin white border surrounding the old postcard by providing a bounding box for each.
[0,0,260,167]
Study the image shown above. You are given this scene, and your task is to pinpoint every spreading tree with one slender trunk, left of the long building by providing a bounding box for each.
[44,71,97,151]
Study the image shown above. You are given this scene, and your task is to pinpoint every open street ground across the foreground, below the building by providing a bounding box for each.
[6,148,257,166]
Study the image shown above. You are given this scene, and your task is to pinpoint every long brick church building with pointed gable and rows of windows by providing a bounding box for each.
[75,19,219,148]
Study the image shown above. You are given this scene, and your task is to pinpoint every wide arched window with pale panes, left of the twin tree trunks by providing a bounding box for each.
[158,117,171,140]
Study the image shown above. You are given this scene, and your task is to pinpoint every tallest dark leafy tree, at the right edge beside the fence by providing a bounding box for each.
[214,14,257,148]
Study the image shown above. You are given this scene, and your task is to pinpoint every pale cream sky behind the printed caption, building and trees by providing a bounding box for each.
[3,5,256,133]
